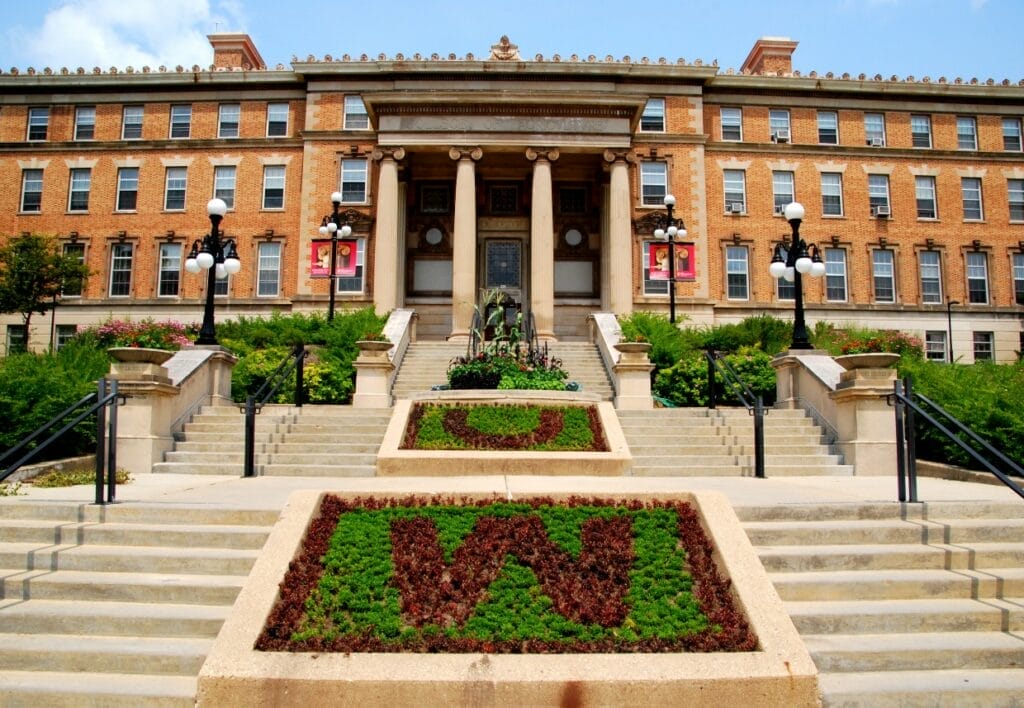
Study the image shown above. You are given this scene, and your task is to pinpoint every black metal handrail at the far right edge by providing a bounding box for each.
[887,376,1024,502]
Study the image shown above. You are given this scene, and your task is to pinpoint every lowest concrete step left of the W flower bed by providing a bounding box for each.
[0,671,199,708]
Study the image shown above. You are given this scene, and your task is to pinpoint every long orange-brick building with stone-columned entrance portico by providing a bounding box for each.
[0,34,1024,362]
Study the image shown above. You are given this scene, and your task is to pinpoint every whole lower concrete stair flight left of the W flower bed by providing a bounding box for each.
[0,499,279,707]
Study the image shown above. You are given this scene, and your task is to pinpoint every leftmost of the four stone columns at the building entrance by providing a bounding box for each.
[372,145,406,315]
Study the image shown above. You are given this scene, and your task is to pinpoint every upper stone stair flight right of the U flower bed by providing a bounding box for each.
[618,408,853,476]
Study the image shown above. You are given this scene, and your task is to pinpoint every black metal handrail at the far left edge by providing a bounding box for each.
[0,378,119,504]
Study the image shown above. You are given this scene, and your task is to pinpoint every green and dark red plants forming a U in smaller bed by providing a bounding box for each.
[401,403,608,452]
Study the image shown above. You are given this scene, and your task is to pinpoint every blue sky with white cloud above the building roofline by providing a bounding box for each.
[0,0,1024,83]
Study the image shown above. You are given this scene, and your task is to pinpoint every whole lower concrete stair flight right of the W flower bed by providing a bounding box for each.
[736,502,1024,707]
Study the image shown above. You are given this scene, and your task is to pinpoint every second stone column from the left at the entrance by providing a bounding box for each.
[449,148,483,340]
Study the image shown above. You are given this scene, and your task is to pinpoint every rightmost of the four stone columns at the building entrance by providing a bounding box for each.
[601,150,633,315]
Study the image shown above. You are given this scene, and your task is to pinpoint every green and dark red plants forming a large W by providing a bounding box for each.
[256,495,757,653]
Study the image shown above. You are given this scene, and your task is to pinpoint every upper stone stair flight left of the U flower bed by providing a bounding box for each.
[153,405,391,476]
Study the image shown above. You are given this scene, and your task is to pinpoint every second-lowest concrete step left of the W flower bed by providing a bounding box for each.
[0,633,213,676]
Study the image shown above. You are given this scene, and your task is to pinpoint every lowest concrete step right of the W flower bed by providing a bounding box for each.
[818,668,1024,708]
